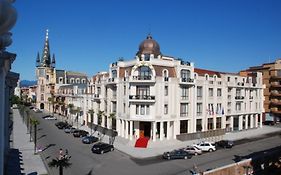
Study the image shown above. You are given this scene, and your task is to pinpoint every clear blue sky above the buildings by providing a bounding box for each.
[7,0,281,80]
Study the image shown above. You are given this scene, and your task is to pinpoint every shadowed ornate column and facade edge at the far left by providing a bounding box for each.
[0,1,19,174]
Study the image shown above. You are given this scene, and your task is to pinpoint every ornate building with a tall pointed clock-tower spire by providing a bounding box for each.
[36,30,87,113]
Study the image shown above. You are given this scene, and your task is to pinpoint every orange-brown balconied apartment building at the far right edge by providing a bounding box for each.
[242,59,281,121]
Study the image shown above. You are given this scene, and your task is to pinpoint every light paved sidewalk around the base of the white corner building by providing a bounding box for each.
[79,123,281,158]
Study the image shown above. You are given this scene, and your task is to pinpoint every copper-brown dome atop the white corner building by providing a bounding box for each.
[137,34,161,57]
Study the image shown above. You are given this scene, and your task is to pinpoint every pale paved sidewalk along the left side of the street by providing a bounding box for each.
[8,109,48,175]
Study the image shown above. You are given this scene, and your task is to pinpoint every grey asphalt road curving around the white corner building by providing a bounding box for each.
[31,110,281,175]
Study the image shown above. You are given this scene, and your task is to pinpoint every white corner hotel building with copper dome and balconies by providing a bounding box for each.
[54,35,263,141]
